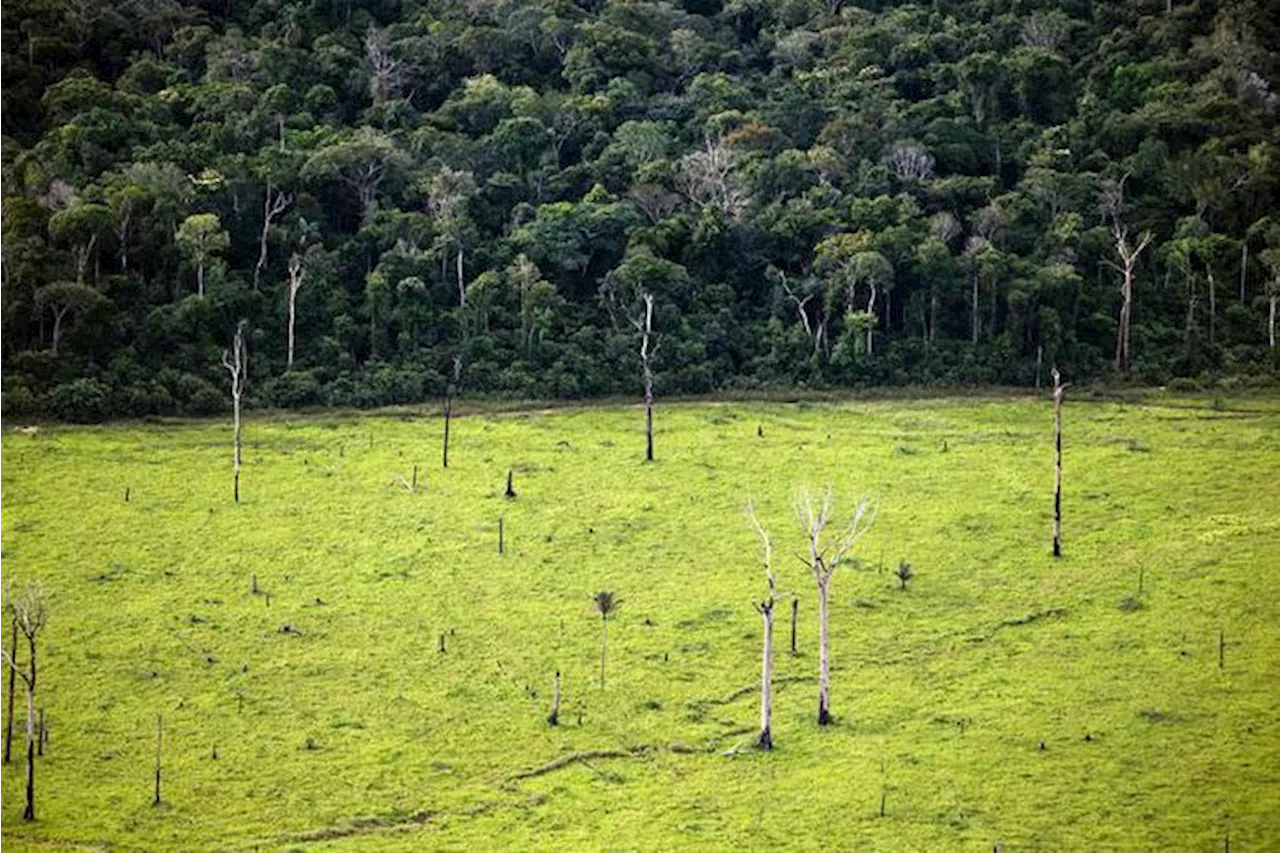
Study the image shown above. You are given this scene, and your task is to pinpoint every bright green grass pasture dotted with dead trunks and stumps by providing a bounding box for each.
[0,398,1280,850]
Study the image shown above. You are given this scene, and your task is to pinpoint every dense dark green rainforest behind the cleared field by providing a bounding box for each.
[0,0,1280,419]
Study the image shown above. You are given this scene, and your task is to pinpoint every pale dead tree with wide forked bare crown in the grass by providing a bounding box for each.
[795,491,876,726]
